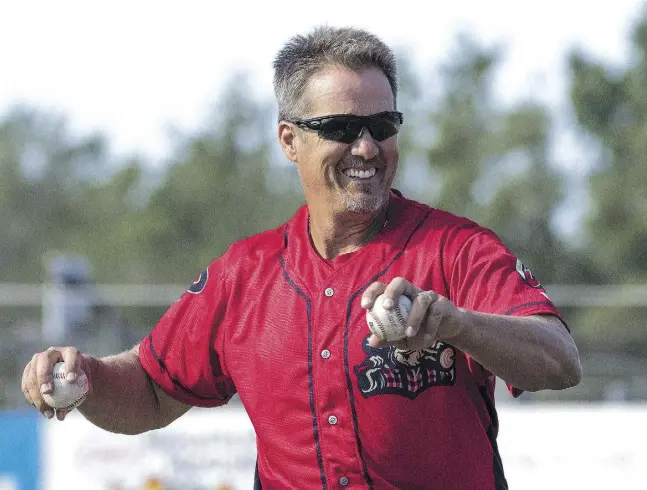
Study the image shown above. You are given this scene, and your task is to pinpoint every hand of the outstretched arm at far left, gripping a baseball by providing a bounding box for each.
[21,347,92,420]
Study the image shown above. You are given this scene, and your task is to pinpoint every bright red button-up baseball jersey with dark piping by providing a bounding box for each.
[139,191,558,490]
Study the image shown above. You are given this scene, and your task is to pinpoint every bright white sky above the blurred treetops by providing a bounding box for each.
[0,0,643,165]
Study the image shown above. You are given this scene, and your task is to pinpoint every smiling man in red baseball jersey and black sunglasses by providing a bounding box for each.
[22,27,581,490]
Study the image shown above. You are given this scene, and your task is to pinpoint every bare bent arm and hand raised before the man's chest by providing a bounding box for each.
[362,278,582,391]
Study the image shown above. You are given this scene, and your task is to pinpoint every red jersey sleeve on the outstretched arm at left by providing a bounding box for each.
[139,257,236,407]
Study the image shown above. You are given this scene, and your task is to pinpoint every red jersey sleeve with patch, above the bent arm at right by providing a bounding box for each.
[449,228,568,397]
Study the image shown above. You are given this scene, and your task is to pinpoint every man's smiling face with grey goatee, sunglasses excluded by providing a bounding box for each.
[279,66,398,213]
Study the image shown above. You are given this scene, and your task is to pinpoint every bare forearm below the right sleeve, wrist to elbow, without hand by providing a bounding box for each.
[447,310,582,391]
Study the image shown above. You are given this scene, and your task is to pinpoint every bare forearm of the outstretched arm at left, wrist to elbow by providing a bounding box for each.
[78,348,160,434]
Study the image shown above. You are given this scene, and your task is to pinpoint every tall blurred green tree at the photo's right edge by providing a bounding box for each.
[569,10,647,356]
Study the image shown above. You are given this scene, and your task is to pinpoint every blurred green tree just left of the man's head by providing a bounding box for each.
[134,75,303,283]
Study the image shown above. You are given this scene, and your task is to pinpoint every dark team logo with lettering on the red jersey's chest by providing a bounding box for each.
[354,336,456,400]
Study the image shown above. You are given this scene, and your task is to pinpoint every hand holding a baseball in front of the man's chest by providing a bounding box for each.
[361,277,461,350]
